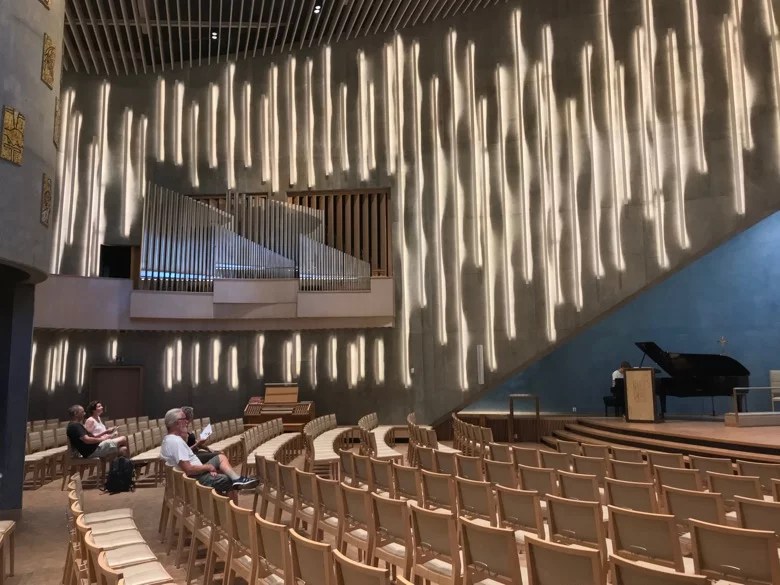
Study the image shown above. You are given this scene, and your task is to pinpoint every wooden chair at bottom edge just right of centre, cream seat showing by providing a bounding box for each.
[409,504,462,585]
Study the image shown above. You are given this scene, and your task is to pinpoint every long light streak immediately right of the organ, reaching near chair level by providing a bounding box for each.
[393,34,412,388]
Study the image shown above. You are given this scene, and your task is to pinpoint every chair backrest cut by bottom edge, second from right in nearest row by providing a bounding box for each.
[525,536,604,585]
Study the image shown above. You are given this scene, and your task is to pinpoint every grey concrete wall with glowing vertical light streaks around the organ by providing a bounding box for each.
[44,0,780,422]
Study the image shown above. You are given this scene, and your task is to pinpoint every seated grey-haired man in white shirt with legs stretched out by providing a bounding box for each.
[160,408,258,494]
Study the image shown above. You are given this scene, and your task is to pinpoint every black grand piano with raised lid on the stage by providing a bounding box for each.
[616,341,750,416]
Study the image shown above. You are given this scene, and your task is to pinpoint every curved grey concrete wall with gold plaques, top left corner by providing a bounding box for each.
[0,0,65,283]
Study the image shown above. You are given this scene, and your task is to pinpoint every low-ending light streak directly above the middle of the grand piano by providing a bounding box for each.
[666,30,691,249]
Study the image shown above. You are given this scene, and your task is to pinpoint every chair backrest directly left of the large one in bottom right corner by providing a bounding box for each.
[608,506,685,571]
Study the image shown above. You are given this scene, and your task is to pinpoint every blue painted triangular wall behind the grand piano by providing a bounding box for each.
[466,212,780,414]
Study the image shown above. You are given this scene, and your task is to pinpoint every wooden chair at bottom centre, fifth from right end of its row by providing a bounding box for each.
[368,494,414,579]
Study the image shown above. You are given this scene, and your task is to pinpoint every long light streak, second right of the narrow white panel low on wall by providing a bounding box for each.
[496,66,523,339]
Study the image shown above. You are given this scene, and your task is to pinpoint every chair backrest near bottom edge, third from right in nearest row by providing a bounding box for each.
[460,518,523,585]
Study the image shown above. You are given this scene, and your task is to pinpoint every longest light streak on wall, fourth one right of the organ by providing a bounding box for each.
[448,29,468,391]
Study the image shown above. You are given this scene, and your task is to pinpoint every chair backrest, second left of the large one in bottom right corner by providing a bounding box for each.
[547,496,607,562]
